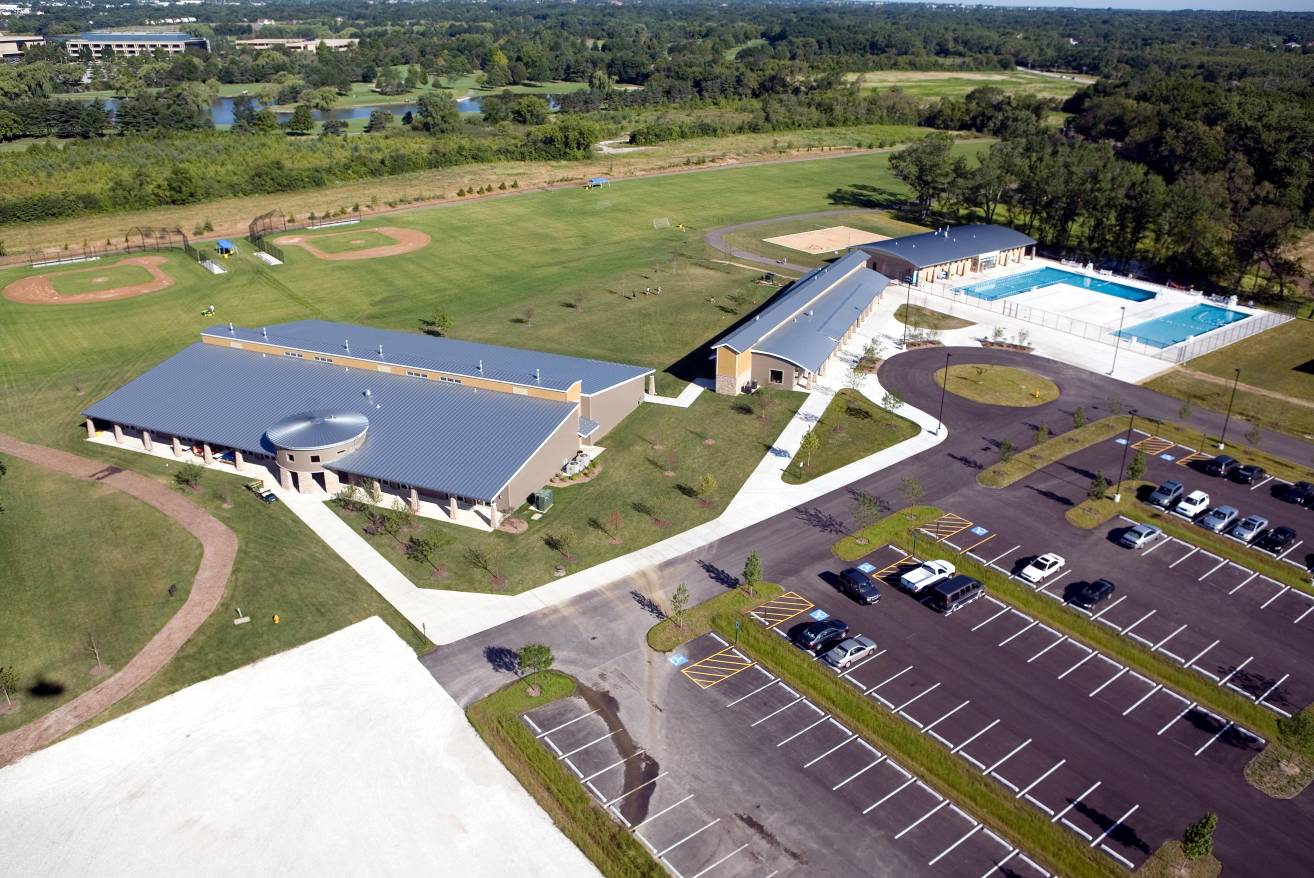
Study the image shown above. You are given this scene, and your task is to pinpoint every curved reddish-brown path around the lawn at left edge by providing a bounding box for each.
[0,432,238,766]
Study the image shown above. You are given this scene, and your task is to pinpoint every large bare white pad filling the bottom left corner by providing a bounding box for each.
[0,618,598,878]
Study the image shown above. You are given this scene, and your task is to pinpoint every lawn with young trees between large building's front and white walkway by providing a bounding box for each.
[331,390,804,593]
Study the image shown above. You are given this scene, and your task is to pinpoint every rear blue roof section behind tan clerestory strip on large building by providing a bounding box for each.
[201,321,652,396]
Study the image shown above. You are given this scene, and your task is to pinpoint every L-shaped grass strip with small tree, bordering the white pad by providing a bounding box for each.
[465,670,668,878]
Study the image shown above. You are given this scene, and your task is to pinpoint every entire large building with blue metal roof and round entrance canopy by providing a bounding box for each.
[83,321,653,527]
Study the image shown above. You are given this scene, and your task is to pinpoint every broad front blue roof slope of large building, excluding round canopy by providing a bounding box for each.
[84,342,579,502]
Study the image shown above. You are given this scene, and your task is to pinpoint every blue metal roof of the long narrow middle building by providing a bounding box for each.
[712,251,890,372]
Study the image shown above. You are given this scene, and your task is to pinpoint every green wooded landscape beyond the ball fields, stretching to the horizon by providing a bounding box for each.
[0,0,1314,298]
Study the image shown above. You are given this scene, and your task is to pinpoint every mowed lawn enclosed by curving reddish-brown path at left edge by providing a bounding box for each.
[0,456,201,732]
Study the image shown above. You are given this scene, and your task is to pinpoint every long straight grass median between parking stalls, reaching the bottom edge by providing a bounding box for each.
[714,612,1125,878]
